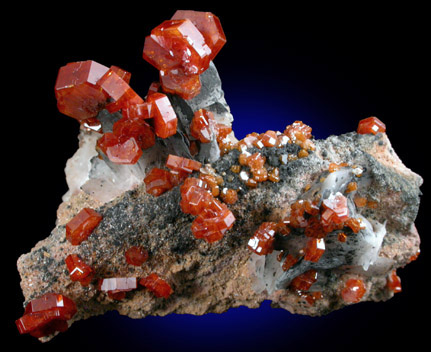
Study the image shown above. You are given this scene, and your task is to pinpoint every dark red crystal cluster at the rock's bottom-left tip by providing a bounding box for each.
[16,293,77,337]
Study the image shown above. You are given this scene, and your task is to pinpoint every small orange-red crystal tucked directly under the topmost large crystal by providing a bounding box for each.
[159,68,201,100]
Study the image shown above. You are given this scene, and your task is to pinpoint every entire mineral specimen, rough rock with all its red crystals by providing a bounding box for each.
[16,11,422,341]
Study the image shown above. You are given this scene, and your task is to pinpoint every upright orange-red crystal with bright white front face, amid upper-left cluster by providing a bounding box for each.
[147,93,177,138]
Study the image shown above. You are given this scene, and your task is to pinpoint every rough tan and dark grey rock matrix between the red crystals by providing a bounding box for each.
[18,62,422,340]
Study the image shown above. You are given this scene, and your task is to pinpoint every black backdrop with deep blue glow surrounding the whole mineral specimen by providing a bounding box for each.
[10,6,429,352]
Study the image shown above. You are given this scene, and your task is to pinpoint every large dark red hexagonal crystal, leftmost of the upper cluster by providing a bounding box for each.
[55,60,109,121]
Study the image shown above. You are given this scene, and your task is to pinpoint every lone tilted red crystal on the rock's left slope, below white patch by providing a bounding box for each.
[66,208,102,246]
